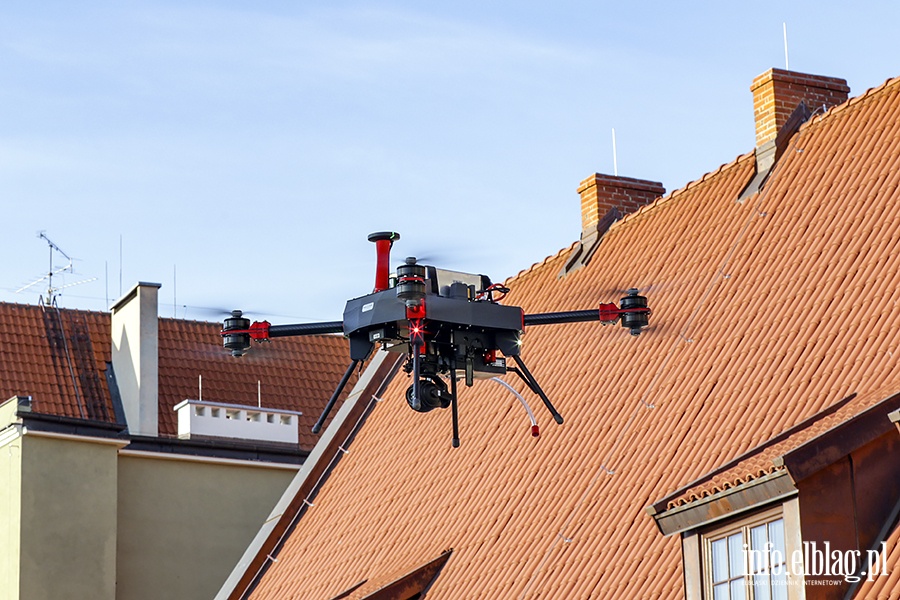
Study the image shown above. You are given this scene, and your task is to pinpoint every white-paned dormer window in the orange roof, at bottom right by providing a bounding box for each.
[702,509,788,600]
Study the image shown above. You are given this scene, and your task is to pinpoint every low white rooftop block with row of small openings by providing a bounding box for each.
[175,400,303,444]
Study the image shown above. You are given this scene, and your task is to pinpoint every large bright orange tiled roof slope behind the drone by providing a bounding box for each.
[243,80,900,599]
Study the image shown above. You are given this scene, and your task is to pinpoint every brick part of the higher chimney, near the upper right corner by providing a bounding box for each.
[750,69,850,148]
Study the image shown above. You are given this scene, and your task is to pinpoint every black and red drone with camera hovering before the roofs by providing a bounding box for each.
[221,231,651,448]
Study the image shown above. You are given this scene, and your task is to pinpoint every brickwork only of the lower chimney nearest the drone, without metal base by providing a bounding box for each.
[578,173,666,232]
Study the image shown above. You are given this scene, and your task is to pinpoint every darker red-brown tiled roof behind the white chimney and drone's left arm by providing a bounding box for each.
[0,303,352,450]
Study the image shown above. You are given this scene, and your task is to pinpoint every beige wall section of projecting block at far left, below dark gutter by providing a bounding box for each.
[14,433,122,600]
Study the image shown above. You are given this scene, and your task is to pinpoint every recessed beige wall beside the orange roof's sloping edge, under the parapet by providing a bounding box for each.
[116,450,299,600]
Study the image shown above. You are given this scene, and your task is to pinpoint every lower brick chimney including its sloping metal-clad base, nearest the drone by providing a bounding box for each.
[559,173,666,277]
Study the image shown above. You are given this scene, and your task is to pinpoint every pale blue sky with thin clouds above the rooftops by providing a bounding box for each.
[0,0,900,322]
